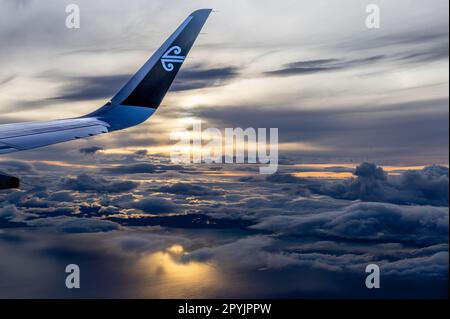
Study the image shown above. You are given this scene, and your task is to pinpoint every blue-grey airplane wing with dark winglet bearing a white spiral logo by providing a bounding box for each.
[0,9,211,156]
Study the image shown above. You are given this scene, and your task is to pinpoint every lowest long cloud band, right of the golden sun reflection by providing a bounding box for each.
[181,235,448,280]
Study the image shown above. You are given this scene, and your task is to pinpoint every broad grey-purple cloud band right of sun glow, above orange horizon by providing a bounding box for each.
[192,99,449,163]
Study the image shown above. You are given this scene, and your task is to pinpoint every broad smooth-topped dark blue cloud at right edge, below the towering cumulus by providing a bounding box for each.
[251,203,449,245]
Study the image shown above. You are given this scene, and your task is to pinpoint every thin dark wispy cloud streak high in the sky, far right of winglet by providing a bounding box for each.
[264,55,385,76]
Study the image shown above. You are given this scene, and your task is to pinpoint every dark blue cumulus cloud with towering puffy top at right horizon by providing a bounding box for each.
[311,163,449,206]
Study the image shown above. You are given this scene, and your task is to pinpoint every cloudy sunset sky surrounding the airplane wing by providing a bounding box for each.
[0,0,449,298]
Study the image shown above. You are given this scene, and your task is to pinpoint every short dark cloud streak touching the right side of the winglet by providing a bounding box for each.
[170,66,239,91]
